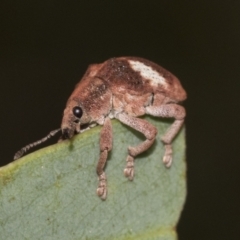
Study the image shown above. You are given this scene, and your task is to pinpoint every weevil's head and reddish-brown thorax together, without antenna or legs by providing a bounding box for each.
[61,76,112,139]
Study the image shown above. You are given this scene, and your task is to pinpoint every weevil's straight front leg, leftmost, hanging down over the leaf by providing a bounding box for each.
[96,118,112,200]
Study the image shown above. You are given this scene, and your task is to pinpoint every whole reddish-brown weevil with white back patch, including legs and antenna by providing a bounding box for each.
[15,57,187,200]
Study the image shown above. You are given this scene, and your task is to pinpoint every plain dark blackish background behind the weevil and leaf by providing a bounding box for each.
[0,0,240,240]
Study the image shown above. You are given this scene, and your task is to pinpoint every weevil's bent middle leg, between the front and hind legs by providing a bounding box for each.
[116,113,157,180]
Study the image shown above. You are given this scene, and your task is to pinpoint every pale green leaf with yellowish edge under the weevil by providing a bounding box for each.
[0,117,186,240]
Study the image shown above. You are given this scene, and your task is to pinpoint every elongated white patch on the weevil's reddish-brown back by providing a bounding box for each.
[128,60,167,86]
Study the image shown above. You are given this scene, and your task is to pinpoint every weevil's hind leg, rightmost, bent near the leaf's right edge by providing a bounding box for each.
[146,103,186,167]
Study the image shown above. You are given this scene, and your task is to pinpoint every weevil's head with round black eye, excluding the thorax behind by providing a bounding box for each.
[61,99,91,139]
